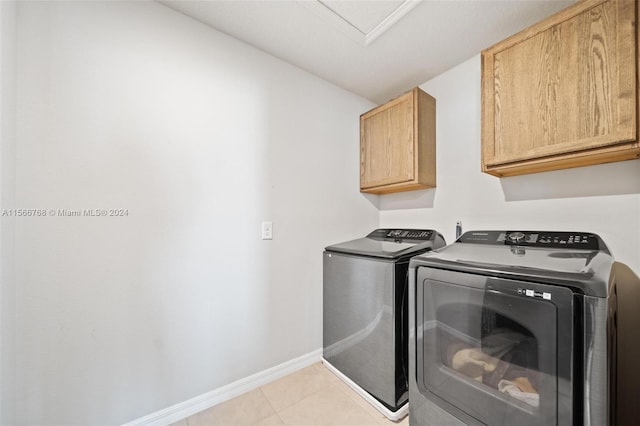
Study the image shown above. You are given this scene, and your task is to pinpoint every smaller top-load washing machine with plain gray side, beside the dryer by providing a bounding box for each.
[322,229,445,420]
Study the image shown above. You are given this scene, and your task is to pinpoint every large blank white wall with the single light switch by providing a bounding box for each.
[15,2,379,425]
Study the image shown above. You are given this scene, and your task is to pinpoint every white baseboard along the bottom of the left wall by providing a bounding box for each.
[122,348,322,426]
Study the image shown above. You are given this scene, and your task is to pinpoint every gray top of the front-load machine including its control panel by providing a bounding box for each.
[410,231,614,297]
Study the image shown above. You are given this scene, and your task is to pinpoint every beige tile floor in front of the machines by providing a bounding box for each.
[172,363,409,426]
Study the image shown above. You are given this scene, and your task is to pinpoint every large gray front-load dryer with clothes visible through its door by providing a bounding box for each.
[409,230,640,426]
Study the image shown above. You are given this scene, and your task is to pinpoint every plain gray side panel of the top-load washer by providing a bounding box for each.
[323,252,406,407]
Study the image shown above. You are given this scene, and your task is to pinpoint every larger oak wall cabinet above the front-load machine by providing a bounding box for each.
[482,0,640,176]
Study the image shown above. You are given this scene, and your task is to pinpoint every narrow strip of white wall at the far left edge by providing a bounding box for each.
[0,0,16,425]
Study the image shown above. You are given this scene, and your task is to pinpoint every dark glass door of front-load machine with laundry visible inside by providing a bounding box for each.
[416,267,574,426]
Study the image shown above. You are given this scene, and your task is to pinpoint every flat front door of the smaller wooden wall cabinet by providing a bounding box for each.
[360,93,415,189]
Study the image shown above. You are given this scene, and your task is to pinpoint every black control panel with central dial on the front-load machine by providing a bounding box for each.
[458,231,604,250]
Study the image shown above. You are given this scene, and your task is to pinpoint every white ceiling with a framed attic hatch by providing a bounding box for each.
[158,0,572,104]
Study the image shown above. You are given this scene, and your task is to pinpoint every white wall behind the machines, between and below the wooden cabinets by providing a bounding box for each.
[379,56,640,274]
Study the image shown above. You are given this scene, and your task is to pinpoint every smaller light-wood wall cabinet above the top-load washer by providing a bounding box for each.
[360,87,436,194]
